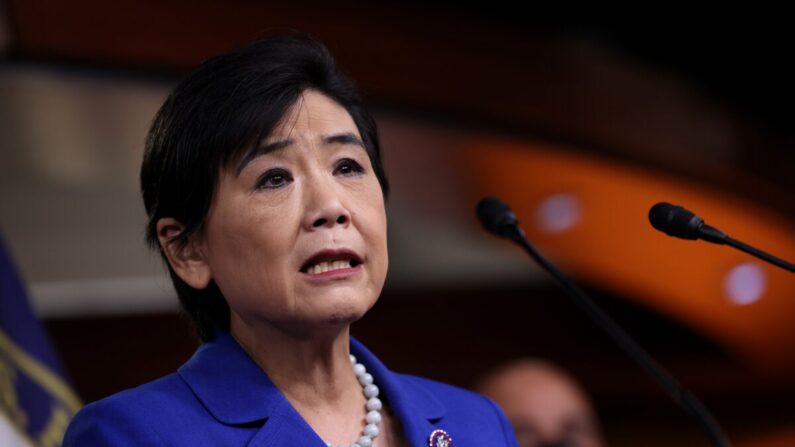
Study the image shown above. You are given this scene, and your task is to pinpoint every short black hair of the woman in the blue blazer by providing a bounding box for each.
[141,35,389,342]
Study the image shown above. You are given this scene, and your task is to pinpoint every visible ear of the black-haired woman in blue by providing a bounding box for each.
[157,217,212,289]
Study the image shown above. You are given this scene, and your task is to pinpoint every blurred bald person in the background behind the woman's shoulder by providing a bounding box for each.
[477,359,605,447]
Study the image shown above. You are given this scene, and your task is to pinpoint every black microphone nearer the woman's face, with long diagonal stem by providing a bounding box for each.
[477,197,731,447]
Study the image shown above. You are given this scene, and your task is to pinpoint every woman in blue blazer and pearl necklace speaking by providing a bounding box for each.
[64,37,515,447]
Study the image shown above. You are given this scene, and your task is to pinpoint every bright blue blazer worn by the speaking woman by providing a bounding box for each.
[63,333,517,447]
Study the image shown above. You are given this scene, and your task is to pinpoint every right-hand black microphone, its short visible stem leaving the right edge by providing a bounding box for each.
[649,202,795,272]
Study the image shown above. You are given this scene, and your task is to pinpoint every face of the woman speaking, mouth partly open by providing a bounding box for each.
[197,90,387,331]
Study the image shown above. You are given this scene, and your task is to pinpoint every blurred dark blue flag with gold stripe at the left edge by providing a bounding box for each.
[0,236,81,447]
